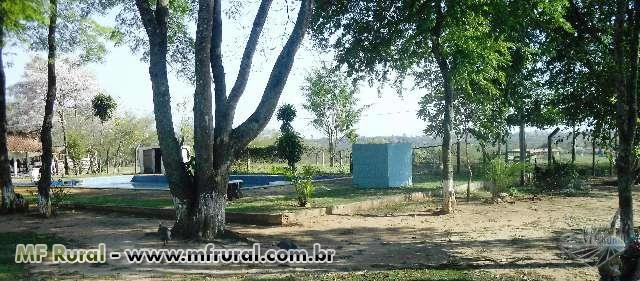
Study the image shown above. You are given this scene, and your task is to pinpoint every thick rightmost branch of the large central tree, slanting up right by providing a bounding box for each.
[231,0,314,154]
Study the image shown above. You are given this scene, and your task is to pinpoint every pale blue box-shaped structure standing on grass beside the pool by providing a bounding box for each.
[352,143,413,188]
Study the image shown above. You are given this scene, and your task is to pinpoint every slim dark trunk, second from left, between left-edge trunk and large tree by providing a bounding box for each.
[38,0,58,217]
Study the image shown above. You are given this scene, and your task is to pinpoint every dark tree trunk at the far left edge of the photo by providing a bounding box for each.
[0,17,15,212]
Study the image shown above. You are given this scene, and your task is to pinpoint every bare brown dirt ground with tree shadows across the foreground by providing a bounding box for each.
[0,178,640,280]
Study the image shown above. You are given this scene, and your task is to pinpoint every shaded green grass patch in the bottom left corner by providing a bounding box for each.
[0,232,74,281]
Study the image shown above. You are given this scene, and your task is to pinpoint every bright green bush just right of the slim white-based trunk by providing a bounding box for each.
[483,157,528,197]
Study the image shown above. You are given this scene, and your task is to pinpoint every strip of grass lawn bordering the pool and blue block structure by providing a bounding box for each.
[18,174,476,213]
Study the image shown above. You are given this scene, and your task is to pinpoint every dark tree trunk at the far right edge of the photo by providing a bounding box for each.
[613,0,640,280]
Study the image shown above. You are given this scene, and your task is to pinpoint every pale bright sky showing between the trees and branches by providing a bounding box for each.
[4,1,425,138]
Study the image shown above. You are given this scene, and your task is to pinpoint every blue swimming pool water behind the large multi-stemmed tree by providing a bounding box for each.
[62,175,344,189]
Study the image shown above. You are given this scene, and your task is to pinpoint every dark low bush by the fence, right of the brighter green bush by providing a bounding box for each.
[535,163,584,193]
